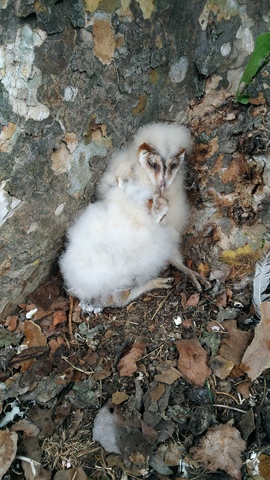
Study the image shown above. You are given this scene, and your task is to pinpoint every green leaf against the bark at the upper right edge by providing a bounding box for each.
[236,32,270,104]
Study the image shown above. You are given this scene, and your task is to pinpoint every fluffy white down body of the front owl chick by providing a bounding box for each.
[60,182,179,306]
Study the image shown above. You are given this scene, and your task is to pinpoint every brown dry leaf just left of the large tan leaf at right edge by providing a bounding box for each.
[218,320,252,365]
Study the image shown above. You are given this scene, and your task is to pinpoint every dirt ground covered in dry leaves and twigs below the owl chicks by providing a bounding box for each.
[0,258,270,480]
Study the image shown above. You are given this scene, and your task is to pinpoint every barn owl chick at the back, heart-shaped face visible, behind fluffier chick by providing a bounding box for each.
[98,123,210,291]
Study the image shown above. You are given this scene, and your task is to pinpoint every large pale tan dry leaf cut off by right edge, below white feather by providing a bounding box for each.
[240,302,270,381]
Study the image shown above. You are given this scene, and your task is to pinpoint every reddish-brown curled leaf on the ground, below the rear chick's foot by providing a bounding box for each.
[176,338,211,387]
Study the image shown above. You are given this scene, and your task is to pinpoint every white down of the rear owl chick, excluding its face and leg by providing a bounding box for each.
[97,123,192,240]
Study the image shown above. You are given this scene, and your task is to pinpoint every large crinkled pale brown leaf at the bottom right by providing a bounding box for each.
[190,424,246,480]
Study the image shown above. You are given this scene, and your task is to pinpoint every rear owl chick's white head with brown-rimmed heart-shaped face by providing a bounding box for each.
[134,123,192,194]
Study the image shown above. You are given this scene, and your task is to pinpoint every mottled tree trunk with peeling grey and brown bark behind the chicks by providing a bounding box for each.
[0,0,270,316]
